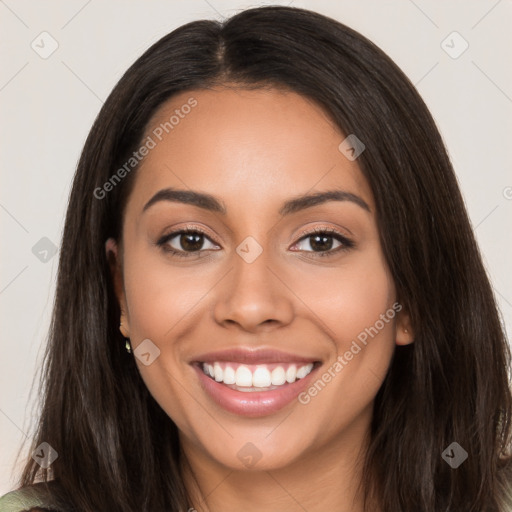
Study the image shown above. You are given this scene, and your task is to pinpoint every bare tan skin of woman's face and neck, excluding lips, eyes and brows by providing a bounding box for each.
[106,87,413,512]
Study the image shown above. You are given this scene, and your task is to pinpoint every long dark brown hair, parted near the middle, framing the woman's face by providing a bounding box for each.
[20,6,512,512]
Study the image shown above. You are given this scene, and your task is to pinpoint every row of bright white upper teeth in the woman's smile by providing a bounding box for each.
[201,362,313,391]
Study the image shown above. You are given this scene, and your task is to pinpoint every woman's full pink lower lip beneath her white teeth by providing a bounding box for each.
[192,364,318,417]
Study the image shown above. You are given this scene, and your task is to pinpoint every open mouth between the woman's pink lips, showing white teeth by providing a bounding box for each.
[197,361,320,392]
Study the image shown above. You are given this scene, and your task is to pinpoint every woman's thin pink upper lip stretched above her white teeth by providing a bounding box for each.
[192,347,318,364]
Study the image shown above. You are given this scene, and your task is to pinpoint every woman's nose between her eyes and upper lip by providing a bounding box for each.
[214,247,294,332]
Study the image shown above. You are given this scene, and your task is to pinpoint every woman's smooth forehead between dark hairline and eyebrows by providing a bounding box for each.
[125,88,373,214]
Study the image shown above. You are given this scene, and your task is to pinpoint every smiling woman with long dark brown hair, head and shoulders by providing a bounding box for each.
[4,7,512,512]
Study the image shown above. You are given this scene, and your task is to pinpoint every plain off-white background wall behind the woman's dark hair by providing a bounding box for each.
[0,0,512,495]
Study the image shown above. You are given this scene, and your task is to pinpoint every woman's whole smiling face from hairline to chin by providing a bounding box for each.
[107,88,411,470]
